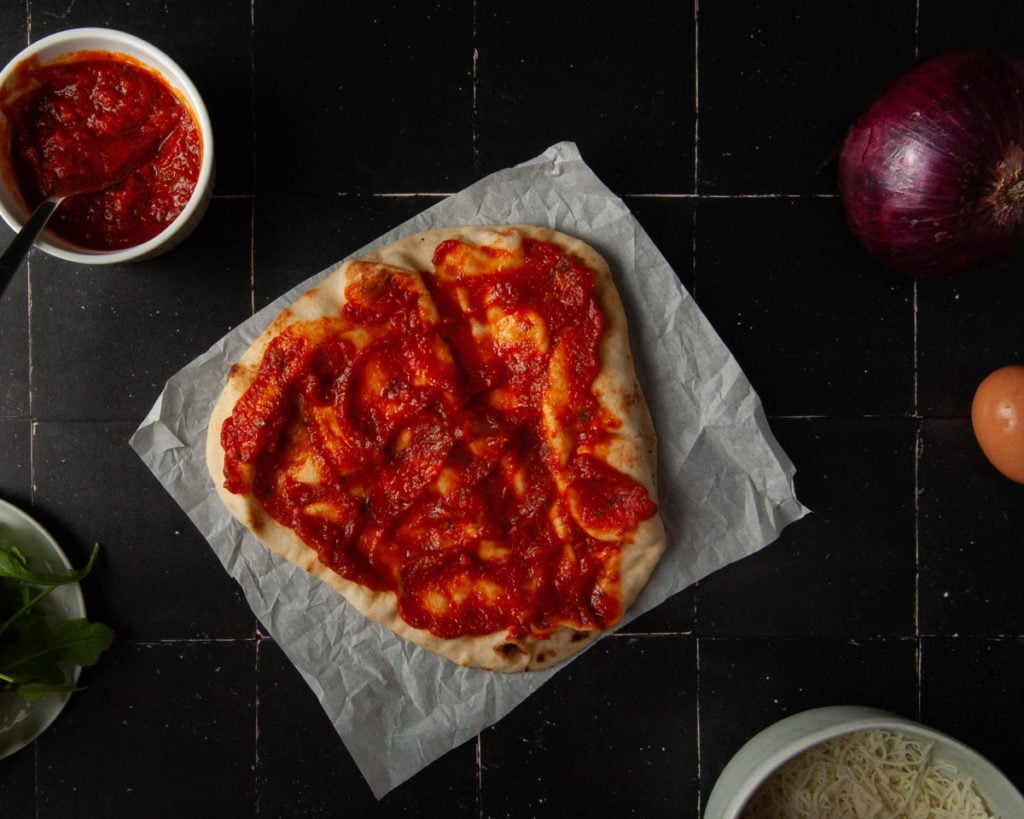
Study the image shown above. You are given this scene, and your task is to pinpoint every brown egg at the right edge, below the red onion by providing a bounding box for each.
[971,364,1024,483]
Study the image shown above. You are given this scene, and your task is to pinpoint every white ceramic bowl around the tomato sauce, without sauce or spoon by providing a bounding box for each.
[0,29,213,264]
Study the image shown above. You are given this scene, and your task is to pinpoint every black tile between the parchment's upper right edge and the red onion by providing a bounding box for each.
[693,198,914,418]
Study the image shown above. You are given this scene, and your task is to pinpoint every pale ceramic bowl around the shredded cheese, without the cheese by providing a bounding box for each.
[703,705,1024,819]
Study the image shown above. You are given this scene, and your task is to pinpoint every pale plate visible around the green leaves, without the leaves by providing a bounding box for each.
[0,500,85,760]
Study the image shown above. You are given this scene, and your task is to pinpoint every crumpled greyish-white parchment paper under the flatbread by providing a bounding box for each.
[131,142,807,799]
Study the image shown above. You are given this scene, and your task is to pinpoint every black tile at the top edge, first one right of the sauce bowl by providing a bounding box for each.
[253,0,476,196]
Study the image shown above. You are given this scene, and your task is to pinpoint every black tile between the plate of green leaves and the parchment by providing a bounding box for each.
[33,421,256,642]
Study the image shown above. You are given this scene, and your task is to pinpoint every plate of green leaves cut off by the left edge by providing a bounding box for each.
[0,500,113,759]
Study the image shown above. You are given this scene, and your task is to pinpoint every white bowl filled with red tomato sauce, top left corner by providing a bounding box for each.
[0,28,214,264]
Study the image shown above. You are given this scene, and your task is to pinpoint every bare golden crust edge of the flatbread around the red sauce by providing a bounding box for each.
[207,225,666,672]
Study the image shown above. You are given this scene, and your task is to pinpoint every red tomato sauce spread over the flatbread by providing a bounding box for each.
[221,241,655,638]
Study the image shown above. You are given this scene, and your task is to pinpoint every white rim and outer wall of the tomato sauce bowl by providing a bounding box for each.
[0,27,213,264]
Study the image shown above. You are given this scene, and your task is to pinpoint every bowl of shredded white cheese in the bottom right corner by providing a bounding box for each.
[703,705,1024,819]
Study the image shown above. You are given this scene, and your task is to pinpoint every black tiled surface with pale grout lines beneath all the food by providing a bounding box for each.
[0,0,1024,817]
